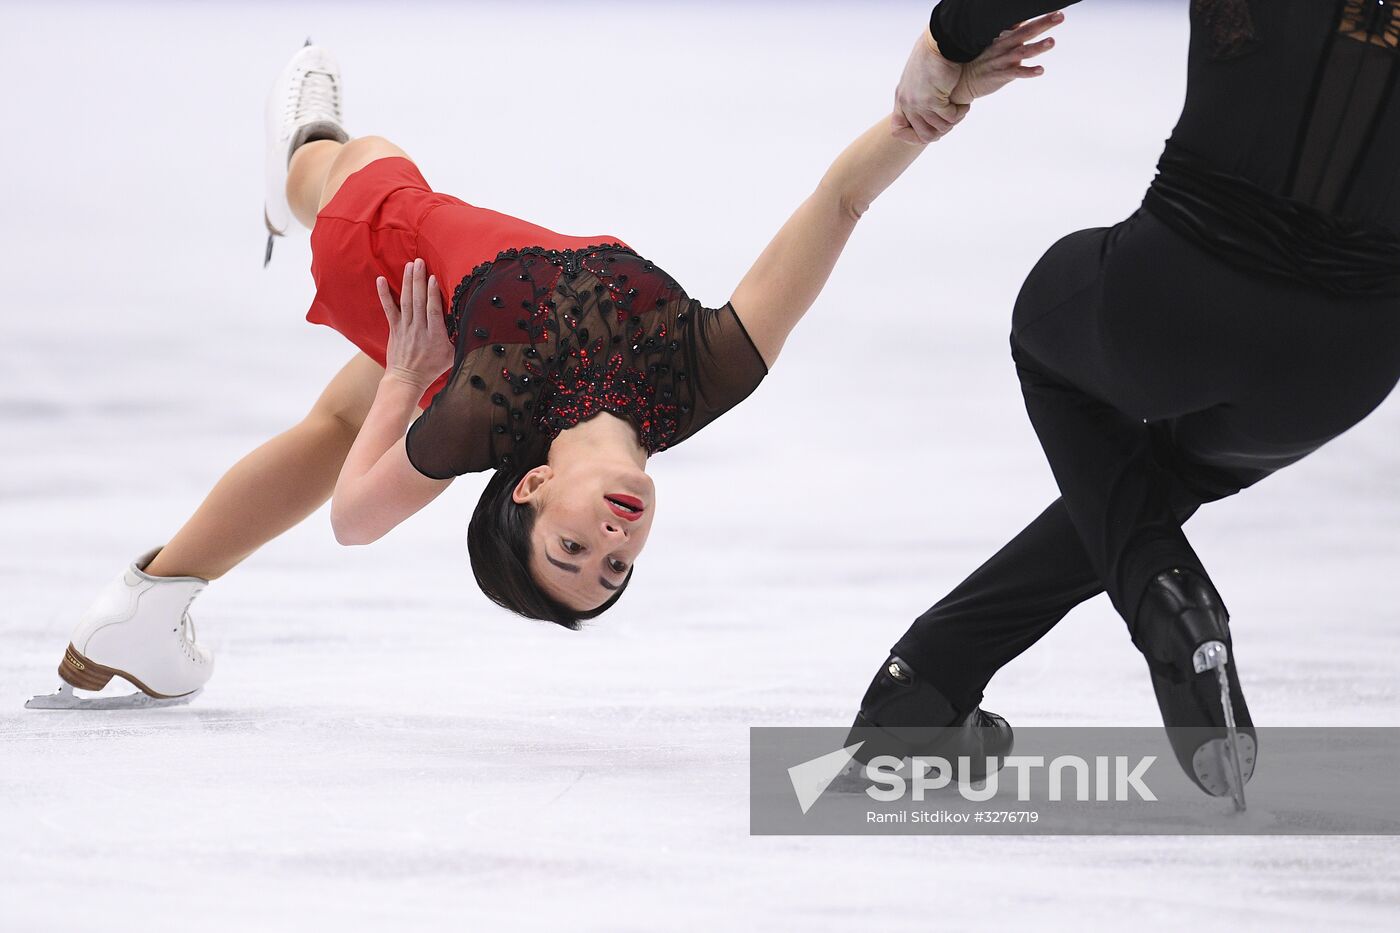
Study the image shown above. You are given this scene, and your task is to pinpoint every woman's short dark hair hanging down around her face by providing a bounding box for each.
[466,467,631,632]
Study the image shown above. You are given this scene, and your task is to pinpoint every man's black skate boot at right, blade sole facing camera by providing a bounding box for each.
[1133,570,1259,810]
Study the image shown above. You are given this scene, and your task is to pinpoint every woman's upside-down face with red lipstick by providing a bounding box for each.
[512,459,657,612]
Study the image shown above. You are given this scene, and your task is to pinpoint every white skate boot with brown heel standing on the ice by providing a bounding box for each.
[25,548,214,709]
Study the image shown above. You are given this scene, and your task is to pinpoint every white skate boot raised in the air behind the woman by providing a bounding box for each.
[263,39,350,266]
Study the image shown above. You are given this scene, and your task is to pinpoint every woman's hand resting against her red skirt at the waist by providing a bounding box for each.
[374,259,455,391]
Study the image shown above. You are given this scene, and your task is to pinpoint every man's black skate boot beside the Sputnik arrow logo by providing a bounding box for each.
[847,656,1014,782]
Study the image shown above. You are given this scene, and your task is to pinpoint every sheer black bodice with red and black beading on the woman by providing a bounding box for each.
[407,244,767,479]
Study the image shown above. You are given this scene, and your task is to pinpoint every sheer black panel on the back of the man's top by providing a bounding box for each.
[1285,0,1400,212]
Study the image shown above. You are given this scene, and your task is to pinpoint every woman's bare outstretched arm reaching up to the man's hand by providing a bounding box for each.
[731,15,1061,368]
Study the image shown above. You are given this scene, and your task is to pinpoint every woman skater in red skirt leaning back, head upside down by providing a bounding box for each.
[29,22,1050,706]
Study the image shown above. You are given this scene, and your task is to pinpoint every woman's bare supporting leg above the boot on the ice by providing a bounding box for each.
[146,353,384,580]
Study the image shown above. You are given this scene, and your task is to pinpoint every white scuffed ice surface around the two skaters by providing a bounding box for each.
[0,1,1400,932]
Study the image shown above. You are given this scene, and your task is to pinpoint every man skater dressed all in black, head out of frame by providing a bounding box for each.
[857,0,1400,808]
